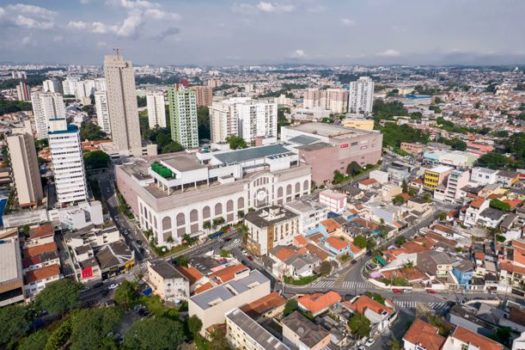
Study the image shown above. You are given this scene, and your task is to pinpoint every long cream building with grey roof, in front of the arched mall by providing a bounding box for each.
[188,270,271,334]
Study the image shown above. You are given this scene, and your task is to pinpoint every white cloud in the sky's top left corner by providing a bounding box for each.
[0,4,57,30]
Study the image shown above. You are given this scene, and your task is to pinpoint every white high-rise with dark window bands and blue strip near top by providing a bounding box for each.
[49,118,88,205]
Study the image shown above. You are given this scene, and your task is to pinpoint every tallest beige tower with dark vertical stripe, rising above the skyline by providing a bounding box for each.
[104,52,142,154]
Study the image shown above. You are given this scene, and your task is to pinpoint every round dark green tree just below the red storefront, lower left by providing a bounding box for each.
[35,278,82,315]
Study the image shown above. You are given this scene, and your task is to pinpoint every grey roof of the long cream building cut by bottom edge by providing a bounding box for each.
[226,308,289,350]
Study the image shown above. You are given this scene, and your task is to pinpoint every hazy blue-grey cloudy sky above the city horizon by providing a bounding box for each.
[0,0,525,65]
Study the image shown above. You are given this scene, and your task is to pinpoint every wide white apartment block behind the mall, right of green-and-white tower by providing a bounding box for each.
[210,97,277,143]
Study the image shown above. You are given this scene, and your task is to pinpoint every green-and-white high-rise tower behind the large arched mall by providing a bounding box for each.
[168,86,199,148]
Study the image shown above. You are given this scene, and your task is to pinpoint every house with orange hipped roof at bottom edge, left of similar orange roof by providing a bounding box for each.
[403,319,445,350]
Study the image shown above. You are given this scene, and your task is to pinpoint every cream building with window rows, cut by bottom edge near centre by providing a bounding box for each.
[225,308,290,350]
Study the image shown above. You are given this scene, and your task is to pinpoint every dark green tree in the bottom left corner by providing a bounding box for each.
[0,305,31,345]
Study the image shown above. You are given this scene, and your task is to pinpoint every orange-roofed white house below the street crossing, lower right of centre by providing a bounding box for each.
[342,295,395,332]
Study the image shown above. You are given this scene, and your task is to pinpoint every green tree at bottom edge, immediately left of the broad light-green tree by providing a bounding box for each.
[71,307,123,350]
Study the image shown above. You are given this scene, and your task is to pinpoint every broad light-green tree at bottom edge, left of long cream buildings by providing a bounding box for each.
[124,317,184,350]
